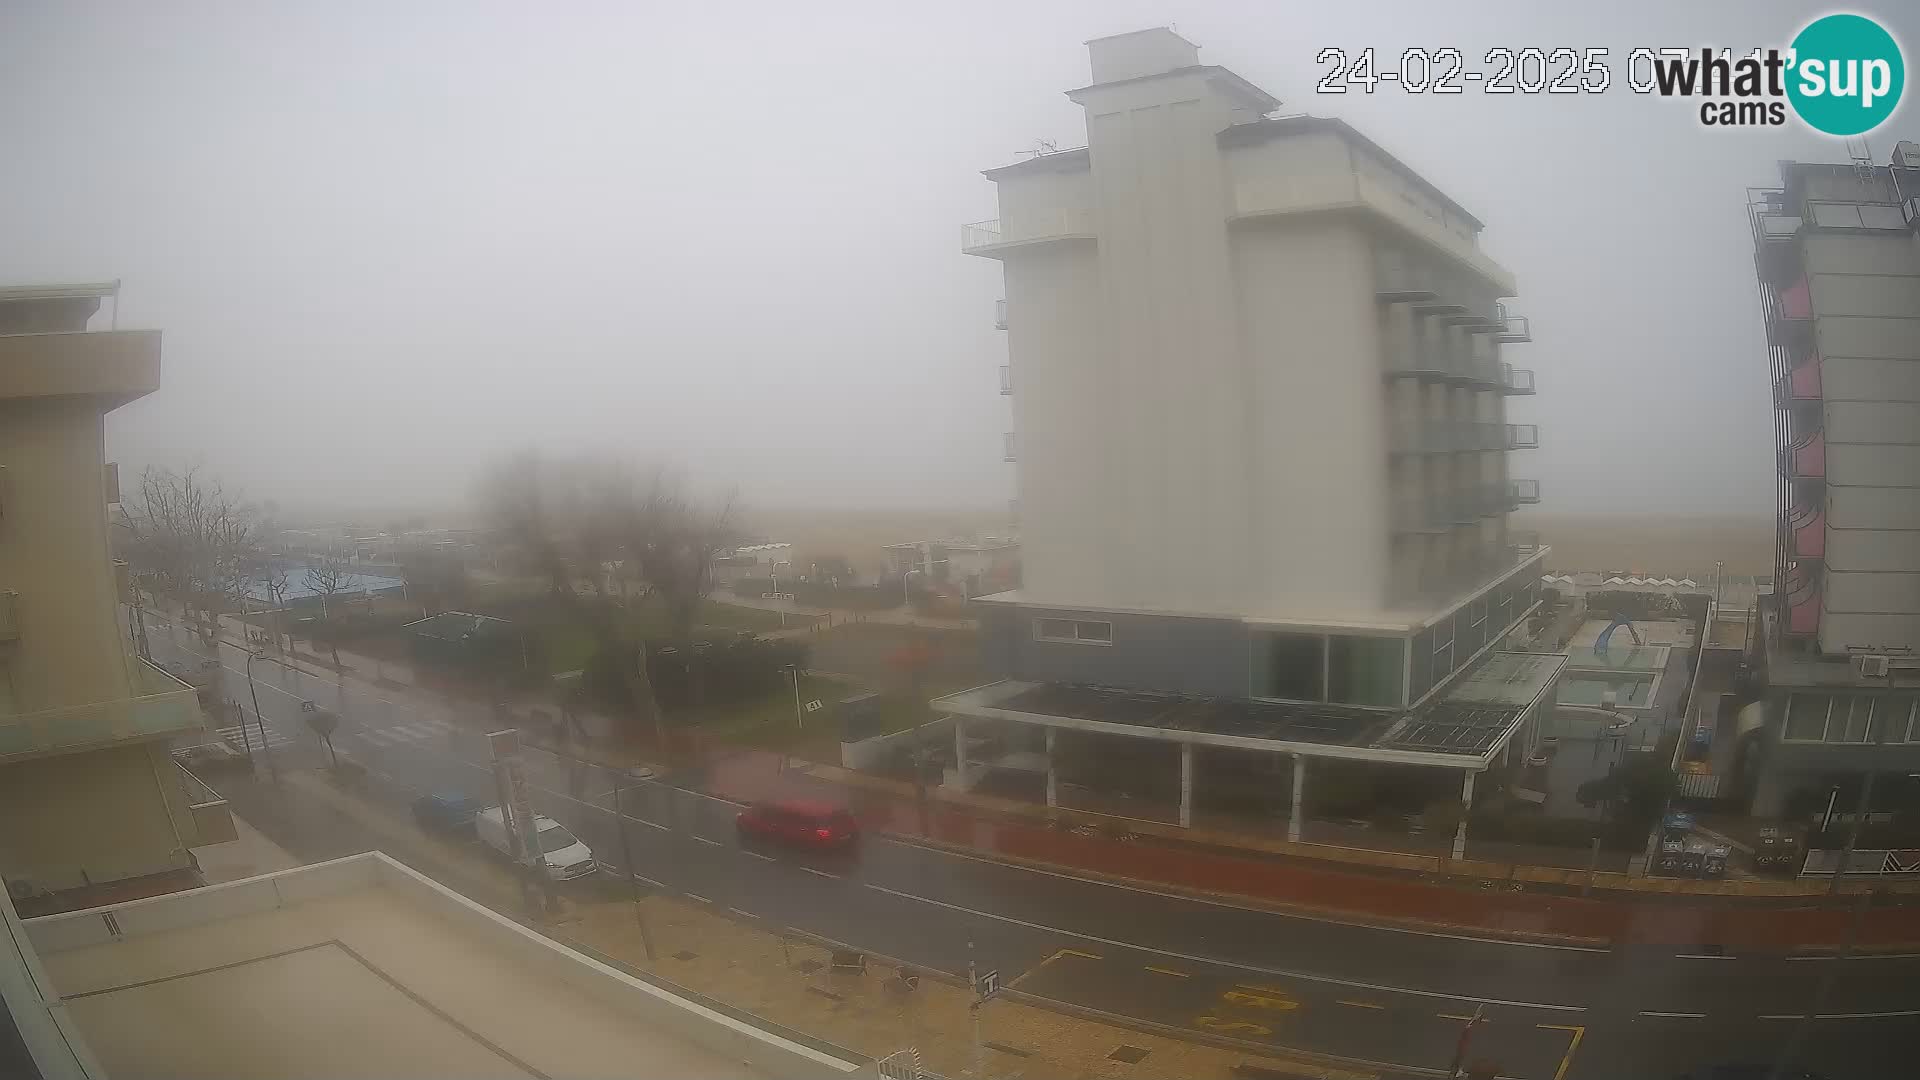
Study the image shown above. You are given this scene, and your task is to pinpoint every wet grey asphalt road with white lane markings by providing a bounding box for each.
[154,630,1920,1080]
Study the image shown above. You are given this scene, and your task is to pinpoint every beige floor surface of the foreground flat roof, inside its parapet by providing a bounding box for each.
[40,857,802,1080]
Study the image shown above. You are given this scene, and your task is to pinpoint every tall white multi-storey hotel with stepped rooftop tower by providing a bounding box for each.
[936,29,1557,845]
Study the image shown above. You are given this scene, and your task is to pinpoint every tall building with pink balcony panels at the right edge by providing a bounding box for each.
[1743,142,1920,819]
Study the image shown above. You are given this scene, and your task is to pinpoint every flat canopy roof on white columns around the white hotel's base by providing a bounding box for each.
[933,651,1567,769]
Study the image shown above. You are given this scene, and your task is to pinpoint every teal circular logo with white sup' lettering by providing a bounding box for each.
[1788,15,1907,135]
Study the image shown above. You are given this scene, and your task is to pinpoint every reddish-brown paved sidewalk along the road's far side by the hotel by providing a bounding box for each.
[707,753,1920,951]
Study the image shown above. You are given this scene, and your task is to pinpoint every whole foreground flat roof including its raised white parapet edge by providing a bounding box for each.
[25,851,858,1080]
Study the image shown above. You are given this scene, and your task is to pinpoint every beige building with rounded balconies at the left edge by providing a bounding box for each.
[0,278,230,901]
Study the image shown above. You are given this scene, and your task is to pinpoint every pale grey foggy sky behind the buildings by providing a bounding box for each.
[0,0,1920,513]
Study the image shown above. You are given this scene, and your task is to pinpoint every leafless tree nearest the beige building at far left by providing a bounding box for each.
[123,467,259,646]
